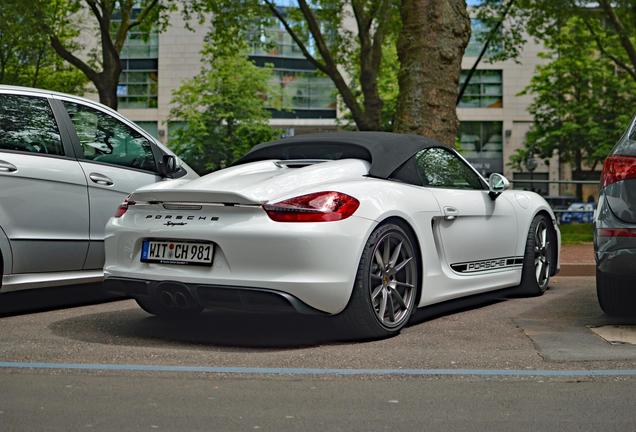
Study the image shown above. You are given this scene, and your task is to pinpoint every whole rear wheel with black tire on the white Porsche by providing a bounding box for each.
[338,223,420,339]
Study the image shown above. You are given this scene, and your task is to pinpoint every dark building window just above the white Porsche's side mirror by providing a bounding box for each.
[459,121,503,176]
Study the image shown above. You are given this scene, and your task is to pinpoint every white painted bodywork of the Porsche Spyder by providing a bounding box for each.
[104,159,558,314]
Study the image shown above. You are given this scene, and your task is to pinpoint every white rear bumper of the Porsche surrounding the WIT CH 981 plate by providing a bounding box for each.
[104,207,376,314]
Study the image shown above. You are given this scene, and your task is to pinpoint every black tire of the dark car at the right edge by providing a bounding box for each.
[596,269,636,317]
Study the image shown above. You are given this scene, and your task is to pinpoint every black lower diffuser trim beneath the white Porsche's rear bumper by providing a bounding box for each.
[104,278,325,315]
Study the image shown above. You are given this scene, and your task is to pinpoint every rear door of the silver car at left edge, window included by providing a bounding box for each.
[0,93,89,274]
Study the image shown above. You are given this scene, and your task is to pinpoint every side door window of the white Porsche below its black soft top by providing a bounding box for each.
[415,148,483,189]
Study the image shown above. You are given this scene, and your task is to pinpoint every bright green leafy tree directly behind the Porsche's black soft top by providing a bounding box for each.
[170,40,280,173]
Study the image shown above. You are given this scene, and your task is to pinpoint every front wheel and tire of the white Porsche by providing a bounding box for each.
[517,214,556,296]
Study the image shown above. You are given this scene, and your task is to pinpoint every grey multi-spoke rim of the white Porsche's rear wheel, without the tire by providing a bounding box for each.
[369,231,417,328]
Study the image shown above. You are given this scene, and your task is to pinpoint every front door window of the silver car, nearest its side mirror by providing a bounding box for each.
[64,102,156,171]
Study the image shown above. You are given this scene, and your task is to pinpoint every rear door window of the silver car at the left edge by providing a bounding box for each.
[0,94,64,156]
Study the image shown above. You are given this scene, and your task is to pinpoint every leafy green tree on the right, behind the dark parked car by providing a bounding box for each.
[511,16,636,194]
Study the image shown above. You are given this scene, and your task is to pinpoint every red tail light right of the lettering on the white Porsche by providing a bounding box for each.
[263,192,360,222]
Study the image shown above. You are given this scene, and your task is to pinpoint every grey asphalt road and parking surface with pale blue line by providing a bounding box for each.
[0,277,636,431]
